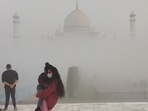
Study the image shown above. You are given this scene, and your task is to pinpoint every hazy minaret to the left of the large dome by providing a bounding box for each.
[13,13,20,38]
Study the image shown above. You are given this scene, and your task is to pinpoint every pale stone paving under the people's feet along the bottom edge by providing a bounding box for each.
[0,102,148,111]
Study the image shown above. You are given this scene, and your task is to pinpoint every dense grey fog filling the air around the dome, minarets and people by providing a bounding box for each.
[0,0,148,100]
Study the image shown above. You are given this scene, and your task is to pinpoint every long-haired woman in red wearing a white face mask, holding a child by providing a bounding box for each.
[36,62,65,110]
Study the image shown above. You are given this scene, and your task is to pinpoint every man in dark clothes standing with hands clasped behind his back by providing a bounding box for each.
[2,64,18,111]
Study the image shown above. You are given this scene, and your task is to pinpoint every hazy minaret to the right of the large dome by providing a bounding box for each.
[129,11,136,37]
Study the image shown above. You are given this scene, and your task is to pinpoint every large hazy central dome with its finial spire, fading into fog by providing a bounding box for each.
[55,3,98,38]
